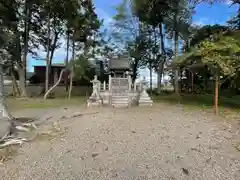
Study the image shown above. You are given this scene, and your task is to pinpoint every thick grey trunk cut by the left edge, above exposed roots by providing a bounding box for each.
[0,64,12,139]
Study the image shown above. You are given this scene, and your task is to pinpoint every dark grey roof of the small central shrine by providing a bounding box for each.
[108,58,130,70]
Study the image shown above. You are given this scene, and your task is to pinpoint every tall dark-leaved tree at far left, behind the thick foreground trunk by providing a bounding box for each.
[1,0,45,97]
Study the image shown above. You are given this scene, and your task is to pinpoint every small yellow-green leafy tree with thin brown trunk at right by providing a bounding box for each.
[175,31,240,115]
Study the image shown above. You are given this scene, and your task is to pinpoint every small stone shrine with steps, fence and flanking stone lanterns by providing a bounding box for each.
[87,58,152,107]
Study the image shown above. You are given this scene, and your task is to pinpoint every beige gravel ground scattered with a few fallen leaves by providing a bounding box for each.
[0,105,240,180]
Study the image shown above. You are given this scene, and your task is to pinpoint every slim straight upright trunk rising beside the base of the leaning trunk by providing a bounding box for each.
[45,13,51,92]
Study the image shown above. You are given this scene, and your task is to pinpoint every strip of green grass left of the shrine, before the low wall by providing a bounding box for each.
[6,97,86,110]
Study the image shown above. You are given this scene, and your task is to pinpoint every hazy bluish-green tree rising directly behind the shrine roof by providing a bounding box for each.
[112,0,147,82]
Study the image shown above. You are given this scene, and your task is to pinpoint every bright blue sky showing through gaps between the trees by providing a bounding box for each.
[28,0,237,80]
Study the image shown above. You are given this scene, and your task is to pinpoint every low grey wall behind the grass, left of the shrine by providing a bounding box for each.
[4,85,92,97]
